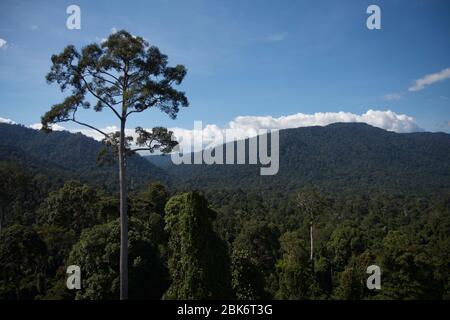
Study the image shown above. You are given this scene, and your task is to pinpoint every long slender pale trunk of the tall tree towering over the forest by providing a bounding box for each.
[119,120,128,300]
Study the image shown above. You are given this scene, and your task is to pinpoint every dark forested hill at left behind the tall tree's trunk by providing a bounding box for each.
[0,123,168,190]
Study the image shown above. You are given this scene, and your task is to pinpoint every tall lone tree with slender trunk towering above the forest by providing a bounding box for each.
[41,30,188,299]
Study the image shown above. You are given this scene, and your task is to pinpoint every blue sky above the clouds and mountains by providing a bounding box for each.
[0,0,450,132]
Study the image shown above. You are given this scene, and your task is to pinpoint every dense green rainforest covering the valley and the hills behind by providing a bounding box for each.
[0,124,450,299]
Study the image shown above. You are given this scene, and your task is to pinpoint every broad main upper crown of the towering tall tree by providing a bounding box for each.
[42,30,189,130]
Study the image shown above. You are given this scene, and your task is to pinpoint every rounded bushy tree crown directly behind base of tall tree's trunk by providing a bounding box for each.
[68,218,168,299]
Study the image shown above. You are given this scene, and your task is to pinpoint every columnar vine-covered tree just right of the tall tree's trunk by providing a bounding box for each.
[165,192,231,299]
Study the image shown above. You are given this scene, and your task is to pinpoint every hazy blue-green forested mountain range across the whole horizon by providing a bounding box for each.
[0,123,450,194]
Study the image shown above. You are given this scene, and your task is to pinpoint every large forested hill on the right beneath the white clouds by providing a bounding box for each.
[147,123,450,194]
